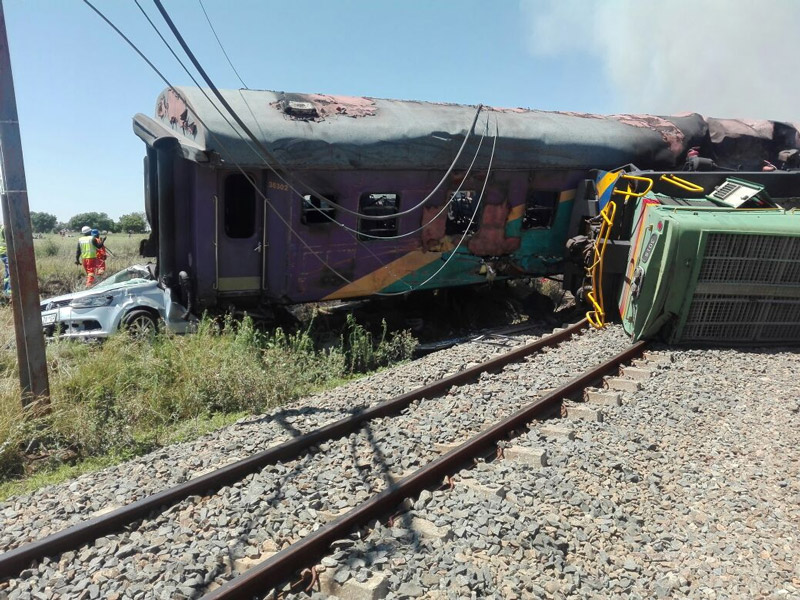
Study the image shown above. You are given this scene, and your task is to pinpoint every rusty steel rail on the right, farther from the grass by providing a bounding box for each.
[203,341,647,600]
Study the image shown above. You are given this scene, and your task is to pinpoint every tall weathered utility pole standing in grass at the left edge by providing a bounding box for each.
[0,0,50,406]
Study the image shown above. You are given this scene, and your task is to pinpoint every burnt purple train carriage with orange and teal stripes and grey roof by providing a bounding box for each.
[133,87,800,313]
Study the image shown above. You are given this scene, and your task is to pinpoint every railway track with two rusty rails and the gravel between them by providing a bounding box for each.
[0,323,643,598]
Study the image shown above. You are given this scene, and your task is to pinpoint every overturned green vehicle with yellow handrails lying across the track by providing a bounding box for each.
[565,166,800,345]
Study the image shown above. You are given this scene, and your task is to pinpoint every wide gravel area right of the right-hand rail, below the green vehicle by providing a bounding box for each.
[315,350,800,599]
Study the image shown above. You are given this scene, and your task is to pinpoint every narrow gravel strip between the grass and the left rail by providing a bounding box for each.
[0,329,549,552]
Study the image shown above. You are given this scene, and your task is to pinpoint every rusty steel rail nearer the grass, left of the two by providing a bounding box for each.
[0,319,586,581]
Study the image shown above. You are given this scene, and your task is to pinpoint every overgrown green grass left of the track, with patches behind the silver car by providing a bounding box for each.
[0,236,415,499]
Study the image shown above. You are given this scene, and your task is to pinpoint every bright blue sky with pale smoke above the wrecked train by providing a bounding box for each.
[3,0,800,220]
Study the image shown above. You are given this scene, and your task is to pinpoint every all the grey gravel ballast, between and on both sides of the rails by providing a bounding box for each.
[0,327,800,598]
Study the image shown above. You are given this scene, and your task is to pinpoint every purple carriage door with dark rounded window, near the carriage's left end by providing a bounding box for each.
[217,172,266,295]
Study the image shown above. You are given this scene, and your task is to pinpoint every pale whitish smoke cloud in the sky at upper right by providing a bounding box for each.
[520,0,800,122]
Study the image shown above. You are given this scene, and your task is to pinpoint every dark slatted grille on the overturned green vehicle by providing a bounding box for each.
[680,233,800,343]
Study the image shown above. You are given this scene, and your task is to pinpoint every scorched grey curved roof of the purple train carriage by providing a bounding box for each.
[134,87,800,175]
